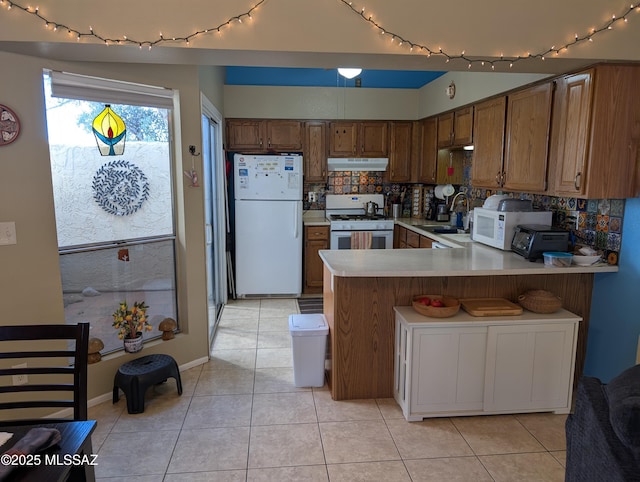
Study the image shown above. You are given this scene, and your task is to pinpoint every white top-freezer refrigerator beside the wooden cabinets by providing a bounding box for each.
[233,154,302,298]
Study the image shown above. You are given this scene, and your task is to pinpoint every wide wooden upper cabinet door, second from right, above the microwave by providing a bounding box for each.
[504,82,553,192]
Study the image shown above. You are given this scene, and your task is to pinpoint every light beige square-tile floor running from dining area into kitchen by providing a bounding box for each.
[89,299,566,482]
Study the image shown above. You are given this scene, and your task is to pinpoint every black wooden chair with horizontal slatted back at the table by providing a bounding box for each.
[0,323,89,420]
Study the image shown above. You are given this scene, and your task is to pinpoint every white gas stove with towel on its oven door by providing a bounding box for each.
[326,194,394,249]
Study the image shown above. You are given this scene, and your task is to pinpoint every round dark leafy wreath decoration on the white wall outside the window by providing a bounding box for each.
[93,161,149,216]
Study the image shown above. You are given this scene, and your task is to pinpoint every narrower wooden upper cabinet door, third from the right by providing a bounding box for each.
[471,97,507,189]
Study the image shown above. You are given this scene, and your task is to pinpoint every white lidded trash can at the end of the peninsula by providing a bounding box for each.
[289,314,329,387]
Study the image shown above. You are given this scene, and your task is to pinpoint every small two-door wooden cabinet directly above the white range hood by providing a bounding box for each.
[329,121,389,157]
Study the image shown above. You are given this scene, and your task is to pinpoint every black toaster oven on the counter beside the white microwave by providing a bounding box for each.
[511,224,569,261]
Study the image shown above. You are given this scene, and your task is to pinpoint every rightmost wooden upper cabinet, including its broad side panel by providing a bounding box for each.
[550,65,640,199]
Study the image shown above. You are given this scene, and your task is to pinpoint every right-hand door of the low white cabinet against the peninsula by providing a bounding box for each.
[484,323,577,412]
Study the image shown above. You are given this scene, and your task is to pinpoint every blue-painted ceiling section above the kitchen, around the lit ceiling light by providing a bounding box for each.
[225,66,445,89]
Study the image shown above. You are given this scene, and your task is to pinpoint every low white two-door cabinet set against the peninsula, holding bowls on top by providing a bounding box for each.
[393,306,582,422]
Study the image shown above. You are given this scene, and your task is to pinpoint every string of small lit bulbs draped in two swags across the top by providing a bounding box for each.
[0,0,640,70]
